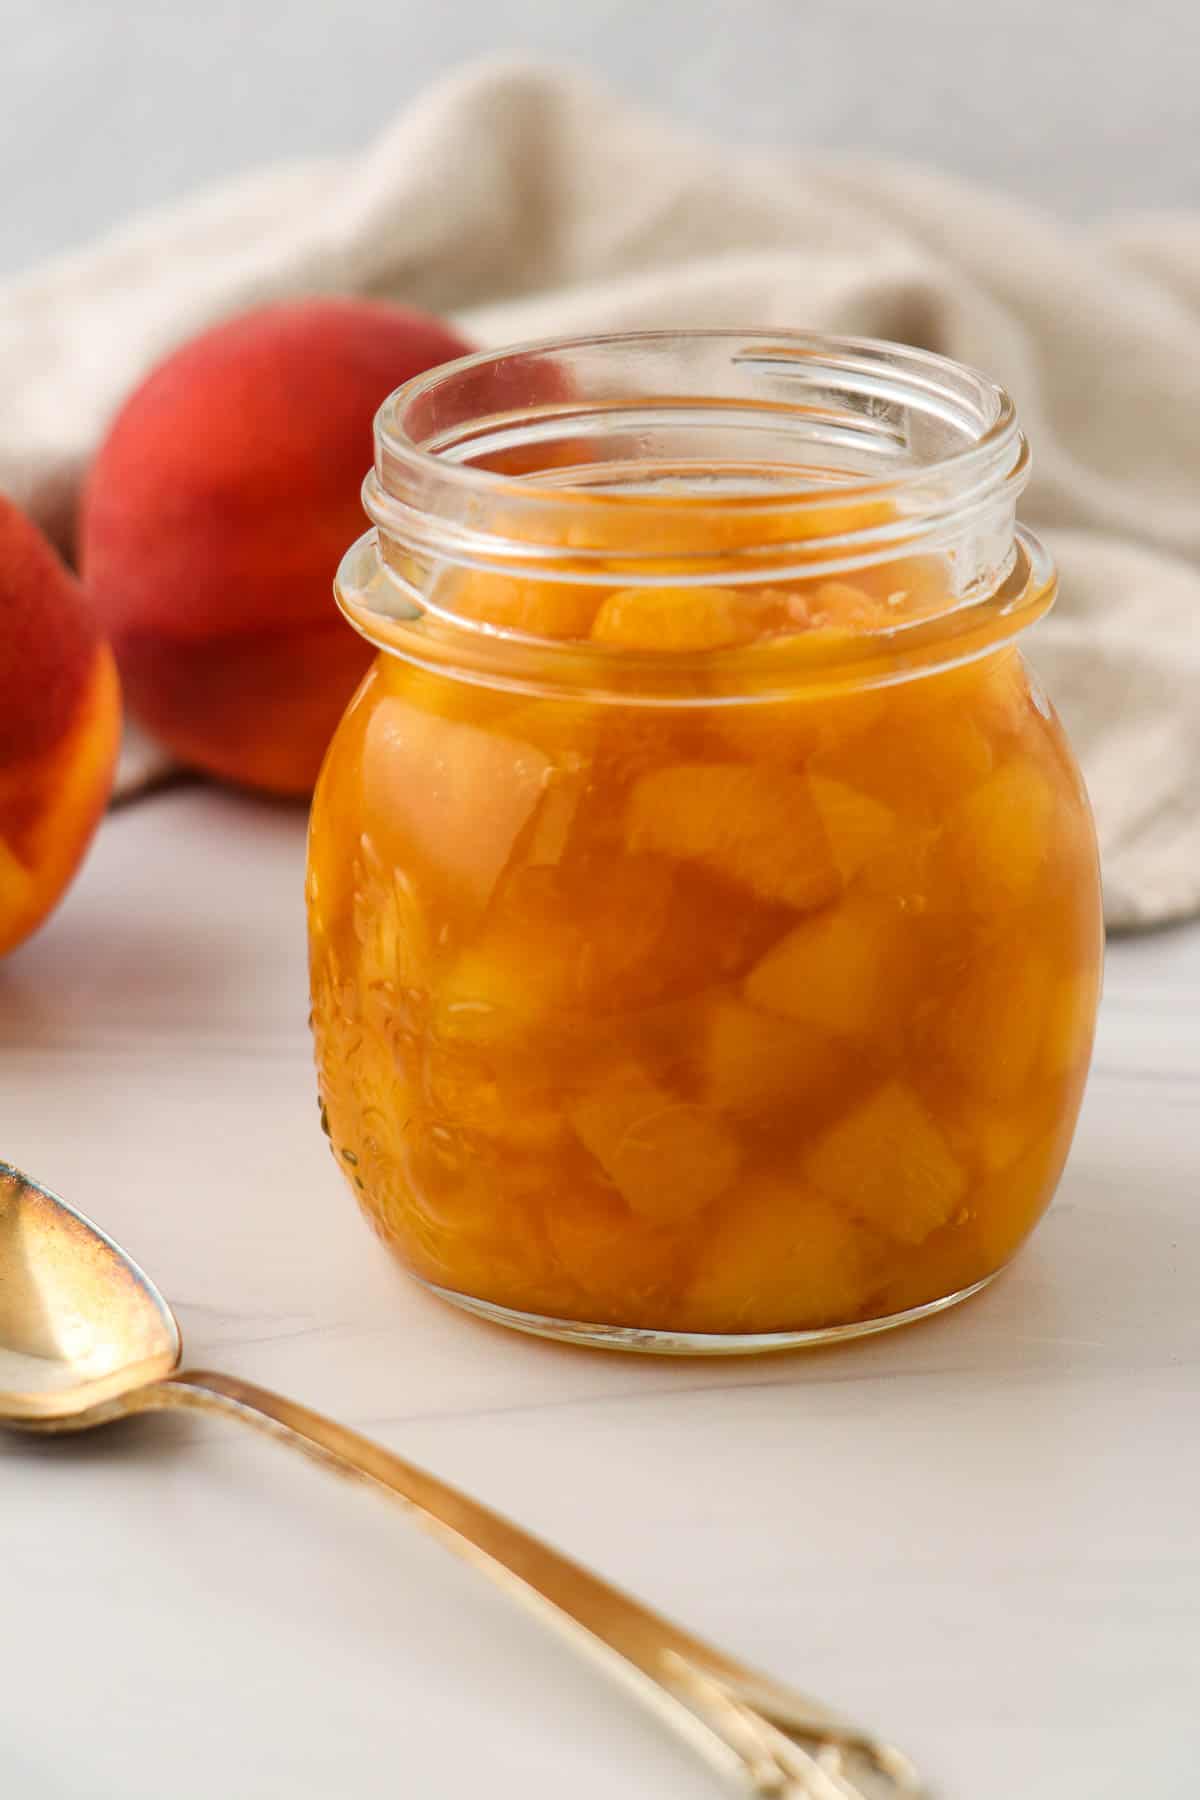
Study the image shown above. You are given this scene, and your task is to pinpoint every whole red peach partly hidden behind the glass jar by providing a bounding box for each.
[81,299,470,794]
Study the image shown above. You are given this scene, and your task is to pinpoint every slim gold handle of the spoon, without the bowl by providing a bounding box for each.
[131,1370,925,1800]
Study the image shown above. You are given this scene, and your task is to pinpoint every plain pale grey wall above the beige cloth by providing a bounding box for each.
[0,0,1200,272]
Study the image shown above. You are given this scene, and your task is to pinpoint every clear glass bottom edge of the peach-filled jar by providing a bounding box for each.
[414,1269,1000,1355]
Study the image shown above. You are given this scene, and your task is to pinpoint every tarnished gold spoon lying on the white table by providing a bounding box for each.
[0,1163,925,1800]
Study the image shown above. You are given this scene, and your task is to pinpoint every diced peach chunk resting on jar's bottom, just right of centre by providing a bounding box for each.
[682,1174,874,1332]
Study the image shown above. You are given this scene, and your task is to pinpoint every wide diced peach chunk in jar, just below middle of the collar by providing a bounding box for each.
[626,763,842,913]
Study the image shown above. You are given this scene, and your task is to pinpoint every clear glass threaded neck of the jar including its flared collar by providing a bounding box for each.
[338,331,1052,689]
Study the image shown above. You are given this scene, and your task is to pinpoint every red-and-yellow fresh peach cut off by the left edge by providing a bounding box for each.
[0,497,121,956]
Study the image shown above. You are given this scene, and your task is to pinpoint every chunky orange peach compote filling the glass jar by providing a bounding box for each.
[308,475,1101,1348]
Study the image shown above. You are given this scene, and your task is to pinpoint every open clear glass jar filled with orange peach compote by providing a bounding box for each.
[308,333,1103,1352]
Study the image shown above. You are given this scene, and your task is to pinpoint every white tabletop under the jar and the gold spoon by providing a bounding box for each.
[0,788,1200,1800]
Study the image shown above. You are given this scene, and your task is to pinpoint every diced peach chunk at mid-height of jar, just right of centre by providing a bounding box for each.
[743,896,900,1039]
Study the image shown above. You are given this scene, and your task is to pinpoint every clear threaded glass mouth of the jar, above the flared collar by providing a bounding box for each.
[363,329,1029,585]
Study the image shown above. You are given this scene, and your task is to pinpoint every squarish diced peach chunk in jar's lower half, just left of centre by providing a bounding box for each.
[569,1066,739,1224]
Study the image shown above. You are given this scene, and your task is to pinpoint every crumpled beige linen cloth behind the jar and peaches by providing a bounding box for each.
[0,61,1200,927]
